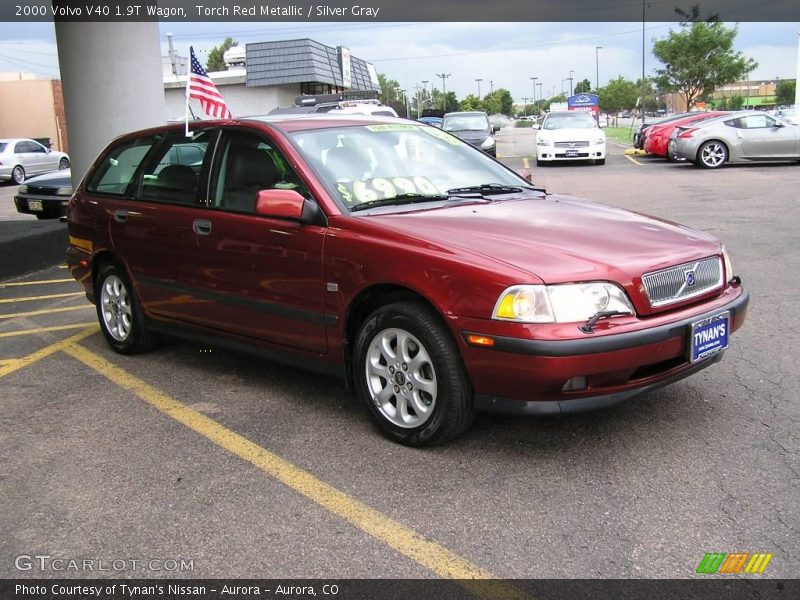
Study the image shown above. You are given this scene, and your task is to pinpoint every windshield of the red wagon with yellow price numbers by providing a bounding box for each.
[290,124,529,210]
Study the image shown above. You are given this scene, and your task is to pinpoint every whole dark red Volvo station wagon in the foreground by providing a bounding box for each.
[67,115,748,445]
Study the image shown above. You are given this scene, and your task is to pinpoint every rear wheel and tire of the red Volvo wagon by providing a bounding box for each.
[95,264,158,354]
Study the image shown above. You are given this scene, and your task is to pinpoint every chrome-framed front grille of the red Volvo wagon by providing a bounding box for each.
[642,256,722,307]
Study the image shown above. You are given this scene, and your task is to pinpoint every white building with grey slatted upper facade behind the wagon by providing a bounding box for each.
[162,38,380,119]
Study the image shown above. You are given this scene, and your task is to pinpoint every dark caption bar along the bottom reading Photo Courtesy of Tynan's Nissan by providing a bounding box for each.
[0,576,800,600]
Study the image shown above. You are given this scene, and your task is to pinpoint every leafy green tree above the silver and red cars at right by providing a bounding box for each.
[653,15,758,110]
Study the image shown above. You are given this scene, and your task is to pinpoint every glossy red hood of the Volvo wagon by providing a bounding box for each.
[369,195,719,287]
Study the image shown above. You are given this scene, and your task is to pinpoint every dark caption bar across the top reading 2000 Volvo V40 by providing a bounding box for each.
[0,0,800,23]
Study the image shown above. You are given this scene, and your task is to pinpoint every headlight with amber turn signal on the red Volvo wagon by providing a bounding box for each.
[492,281,634,323]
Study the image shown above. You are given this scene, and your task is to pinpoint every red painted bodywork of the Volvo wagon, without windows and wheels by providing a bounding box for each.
[68,115,745,412]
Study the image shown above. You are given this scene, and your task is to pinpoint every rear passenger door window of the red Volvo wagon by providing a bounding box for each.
[141,131,211,204]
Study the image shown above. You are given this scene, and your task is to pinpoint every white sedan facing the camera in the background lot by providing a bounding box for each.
[533,111,606,166]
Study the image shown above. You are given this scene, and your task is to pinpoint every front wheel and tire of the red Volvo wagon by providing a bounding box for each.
[353,302,475,446]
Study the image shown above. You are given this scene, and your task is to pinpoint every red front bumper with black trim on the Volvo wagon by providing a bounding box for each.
[459,287,749,414]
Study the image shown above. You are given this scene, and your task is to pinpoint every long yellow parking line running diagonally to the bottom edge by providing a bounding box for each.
[62,343,527,599]
